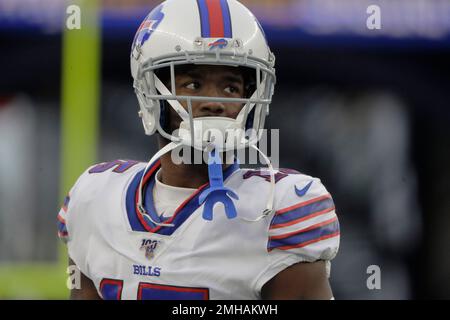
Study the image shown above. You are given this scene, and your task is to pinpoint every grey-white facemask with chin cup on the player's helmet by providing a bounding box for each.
[134,51,275,152]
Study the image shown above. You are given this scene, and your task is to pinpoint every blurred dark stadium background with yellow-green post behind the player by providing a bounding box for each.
[0,0,450,299]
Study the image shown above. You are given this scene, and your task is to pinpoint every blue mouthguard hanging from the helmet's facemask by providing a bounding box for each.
[198,148,239,221]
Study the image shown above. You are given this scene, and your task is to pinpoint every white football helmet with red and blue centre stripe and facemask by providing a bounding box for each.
[131,0,276,151]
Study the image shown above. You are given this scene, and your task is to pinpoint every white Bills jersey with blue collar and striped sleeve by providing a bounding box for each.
[58,160,339,300]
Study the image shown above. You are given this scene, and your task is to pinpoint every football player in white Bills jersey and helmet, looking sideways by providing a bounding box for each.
[58,0,340,299]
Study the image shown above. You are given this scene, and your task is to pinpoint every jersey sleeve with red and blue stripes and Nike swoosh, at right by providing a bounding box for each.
[267,169,340,261]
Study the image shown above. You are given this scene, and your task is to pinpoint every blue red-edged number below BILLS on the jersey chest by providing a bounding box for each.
[100,279,209,300]
